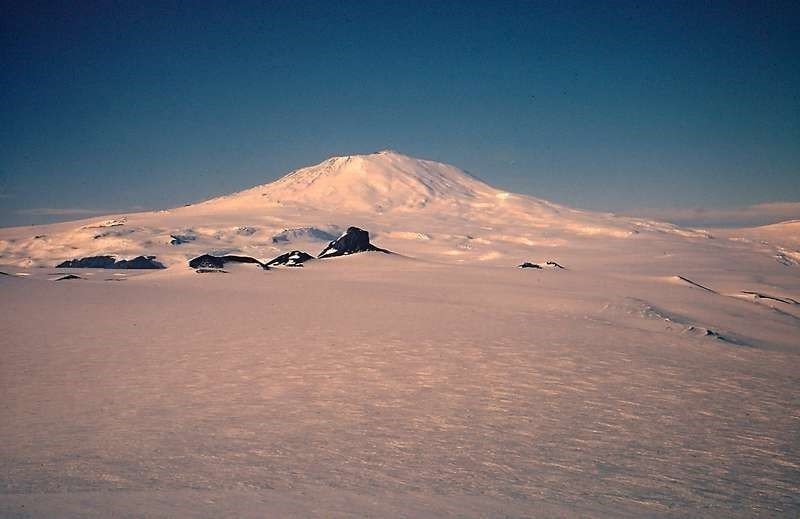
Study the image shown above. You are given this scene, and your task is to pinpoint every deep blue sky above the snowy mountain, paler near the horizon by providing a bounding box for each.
[0,0,800,226]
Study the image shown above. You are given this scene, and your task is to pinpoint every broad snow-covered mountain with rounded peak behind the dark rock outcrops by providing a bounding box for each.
[0,151,724,266]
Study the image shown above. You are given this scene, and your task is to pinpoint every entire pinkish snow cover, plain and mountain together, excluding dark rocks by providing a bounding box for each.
[0,152,800,517]
